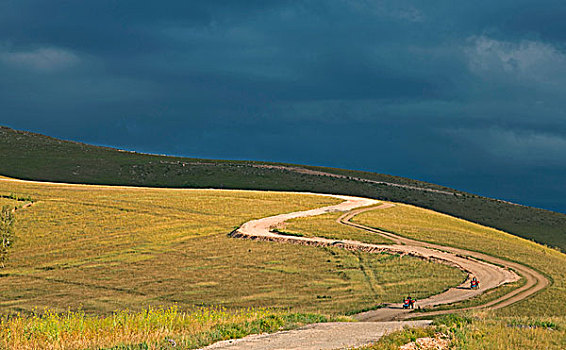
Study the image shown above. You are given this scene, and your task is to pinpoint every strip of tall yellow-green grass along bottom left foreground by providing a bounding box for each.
[0,306,338,350]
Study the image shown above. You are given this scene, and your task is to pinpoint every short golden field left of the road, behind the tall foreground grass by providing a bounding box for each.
[0,178,463,314]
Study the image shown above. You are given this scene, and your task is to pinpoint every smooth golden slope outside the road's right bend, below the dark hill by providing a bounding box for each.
[353,204,566,317]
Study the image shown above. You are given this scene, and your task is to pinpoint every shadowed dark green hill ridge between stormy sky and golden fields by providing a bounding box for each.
[0,127,566,251]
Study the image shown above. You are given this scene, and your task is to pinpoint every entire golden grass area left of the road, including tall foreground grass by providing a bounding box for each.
[0,180,465,349]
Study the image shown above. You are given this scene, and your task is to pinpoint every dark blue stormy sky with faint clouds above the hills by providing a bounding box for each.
[0,0,566,212]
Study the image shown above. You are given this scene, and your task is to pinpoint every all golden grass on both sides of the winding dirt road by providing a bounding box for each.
[4,181,566,349]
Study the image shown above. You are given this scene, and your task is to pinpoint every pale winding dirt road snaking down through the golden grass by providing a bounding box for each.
[210,195,549,350]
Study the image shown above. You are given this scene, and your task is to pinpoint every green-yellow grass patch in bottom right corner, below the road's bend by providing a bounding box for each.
[359,312,566,350]
